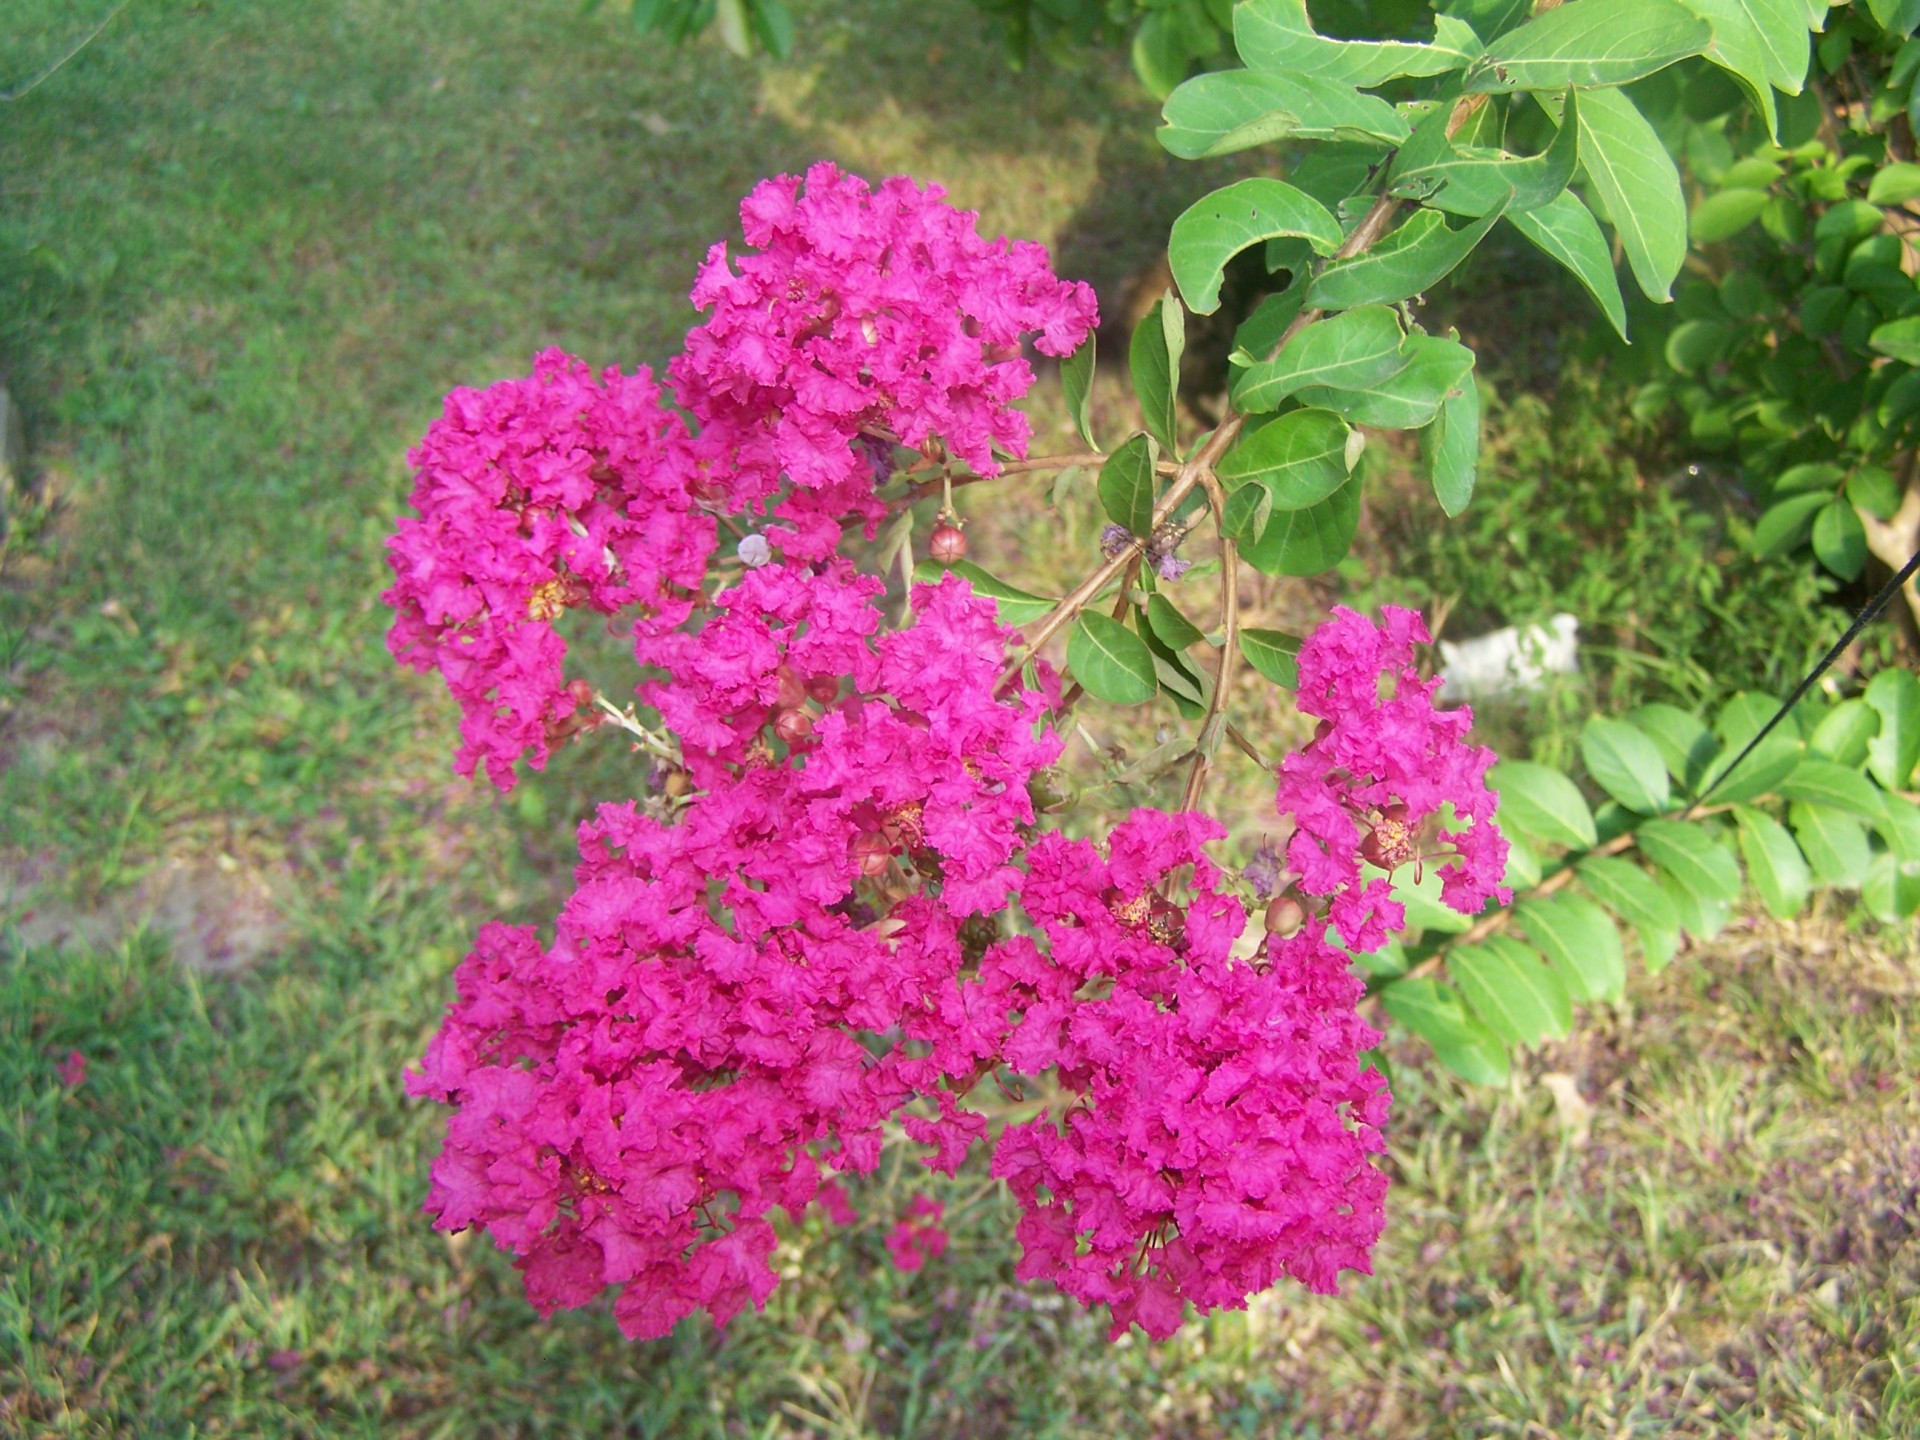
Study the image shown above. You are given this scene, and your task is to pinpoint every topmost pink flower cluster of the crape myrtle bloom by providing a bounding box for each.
[670,161,1096,559]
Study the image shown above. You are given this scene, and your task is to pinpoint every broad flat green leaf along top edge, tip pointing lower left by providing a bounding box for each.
[1465,0,1713,92]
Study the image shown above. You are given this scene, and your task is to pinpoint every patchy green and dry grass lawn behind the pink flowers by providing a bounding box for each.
[0,0,1920,1440]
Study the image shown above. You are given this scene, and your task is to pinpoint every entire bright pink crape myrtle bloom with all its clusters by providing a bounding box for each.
[386,165,1503,1336]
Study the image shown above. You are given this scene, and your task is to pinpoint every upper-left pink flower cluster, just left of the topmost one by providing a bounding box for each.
[382,349,714,789]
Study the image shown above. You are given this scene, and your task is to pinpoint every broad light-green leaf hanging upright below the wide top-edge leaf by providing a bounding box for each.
[1580,90,1688,300]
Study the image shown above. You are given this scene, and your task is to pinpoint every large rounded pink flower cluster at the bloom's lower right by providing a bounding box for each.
[993,810,1390,1338]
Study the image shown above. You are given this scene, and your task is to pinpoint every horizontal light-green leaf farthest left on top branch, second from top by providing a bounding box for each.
[1160,69,1409,159]
